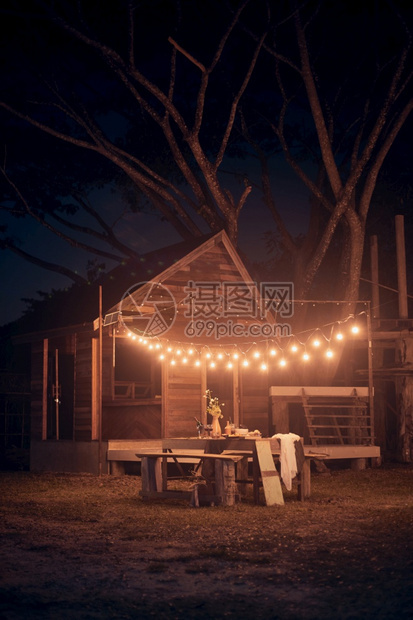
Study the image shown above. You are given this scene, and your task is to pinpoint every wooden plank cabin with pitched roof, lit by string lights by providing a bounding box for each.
[20,231,376,473]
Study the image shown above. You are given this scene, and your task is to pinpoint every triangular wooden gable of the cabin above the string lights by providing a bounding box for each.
[106,231,274,346]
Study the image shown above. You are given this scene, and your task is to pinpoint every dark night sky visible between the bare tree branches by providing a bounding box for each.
[0,0,412,325]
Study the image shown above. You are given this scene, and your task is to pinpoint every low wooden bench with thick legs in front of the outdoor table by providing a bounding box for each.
[135,451,245,506]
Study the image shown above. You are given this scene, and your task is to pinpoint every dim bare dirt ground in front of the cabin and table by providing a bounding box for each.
[0,465,413,620]
